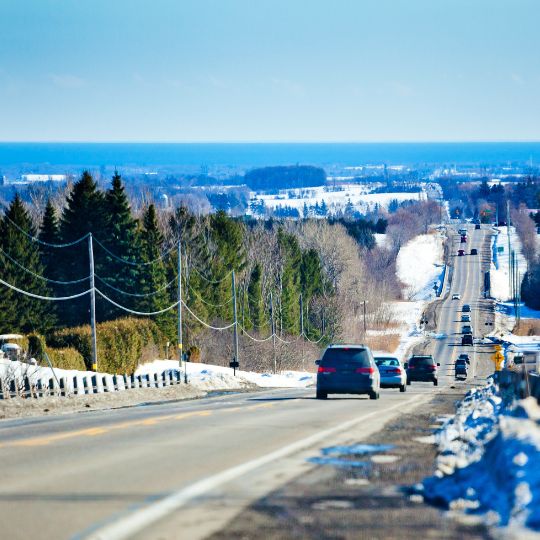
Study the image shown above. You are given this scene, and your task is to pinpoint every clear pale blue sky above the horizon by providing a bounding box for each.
[0,0,540,142]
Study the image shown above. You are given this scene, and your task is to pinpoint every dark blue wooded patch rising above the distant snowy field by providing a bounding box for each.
[244,165,326,191]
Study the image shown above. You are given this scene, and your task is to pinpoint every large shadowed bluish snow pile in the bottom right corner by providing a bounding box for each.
[422,383,540,532]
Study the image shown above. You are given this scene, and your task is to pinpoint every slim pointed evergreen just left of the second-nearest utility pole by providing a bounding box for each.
[139,204,176,340]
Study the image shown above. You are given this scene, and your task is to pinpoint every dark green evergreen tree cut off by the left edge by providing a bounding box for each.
[0,194,55,333]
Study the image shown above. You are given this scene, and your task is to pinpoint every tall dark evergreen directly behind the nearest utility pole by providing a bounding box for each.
[58,171,106,326]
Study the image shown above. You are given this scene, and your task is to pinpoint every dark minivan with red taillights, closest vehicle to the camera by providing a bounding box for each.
[316,345,381,399]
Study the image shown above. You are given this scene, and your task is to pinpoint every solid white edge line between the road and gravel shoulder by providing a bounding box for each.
[87,392,431,540]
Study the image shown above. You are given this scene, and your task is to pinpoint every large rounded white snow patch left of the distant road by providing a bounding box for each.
[396,234,444,300]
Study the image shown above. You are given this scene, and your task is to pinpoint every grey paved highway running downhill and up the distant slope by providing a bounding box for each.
[0,225,492,540]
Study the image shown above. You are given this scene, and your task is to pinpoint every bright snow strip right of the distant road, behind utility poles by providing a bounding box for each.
[490,227,527,301]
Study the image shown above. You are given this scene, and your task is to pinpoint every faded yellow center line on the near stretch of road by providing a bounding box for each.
[0,403,274,449]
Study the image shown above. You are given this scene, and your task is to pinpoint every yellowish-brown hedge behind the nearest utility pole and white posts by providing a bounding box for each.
[48,318,167,374]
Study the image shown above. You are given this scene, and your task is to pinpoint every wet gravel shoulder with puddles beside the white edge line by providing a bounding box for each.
[211,384,490,540]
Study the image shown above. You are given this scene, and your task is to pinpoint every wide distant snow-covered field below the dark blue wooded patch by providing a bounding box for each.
[250,184,426,215]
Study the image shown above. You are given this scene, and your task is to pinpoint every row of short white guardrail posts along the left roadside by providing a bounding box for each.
[0,369,182,399]
